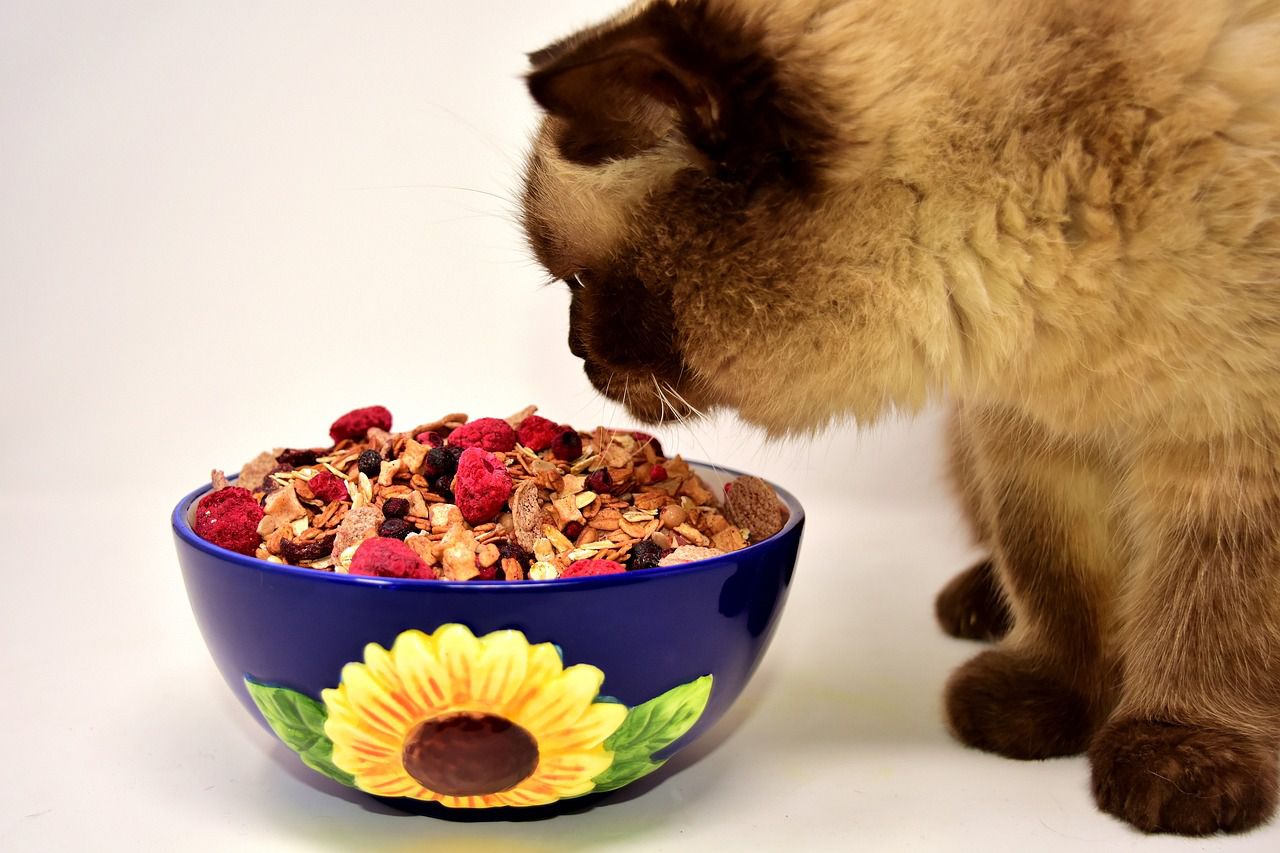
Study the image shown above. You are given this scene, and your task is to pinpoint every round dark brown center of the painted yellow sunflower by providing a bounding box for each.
[403,711,538,797]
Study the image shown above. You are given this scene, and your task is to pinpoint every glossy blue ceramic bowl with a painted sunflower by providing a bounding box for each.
[173,465,804,813]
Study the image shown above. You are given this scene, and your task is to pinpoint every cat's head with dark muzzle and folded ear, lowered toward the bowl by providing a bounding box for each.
[524,0,901,432]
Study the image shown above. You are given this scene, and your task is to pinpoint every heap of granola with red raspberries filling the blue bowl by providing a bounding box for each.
[196,406,787,580]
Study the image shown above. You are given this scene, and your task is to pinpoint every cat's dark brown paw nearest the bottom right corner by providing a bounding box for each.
[1089,719,1277,835]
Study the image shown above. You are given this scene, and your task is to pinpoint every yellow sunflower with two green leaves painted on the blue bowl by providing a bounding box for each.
[246,624,712,808]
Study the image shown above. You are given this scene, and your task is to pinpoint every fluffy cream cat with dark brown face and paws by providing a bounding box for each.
[522,0,1280,835]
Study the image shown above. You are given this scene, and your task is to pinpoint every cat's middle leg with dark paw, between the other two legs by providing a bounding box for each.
[946,409,1119,758]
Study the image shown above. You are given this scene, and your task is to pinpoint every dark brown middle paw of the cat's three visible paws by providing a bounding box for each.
[946,649,1094,760]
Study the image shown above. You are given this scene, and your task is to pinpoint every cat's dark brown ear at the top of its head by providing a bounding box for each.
[527,4,721,165]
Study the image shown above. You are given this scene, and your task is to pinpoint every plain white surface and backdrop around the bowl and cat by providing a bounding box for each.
[0,0,1280,850]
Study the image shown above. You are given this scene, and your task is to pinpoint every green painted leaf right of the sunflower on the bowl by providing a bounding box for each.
[594,675,712,793]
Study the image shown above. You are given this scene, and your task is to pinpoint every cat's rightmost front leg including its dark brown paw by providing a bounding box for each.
[1089,438,1280,835]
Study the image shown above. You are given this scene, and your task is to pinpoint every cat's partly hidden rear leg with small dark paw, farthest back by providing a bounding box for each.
[933,407,1010,640]
